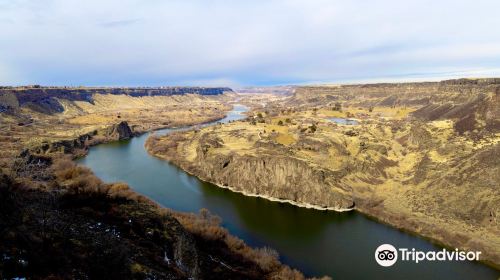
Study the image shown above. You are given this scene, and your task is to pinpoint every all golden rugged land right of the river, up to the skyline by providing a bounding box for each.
[146,79,500,267]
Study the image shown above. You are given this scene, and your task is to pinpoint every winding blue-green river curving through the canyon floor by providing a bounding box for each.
[78,105,500,280]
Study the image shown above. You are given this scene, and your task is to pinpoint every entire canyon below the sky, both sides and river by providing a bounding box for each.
[0,79,500,279]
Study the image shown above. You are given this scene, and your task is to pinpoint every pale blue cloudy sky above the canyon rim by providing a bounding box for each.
[0,0,500,87]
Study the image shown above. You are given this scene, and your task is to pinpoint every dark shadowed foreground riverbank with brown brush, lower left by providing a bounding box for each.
[0,158,312,280]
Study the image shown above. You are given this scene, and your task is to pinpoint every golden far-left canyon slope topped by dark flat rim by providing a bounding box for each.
[0,87,234,172]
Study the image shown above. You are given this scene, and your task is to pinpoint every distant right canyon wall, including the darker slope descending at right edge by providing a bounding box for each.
[288,78,500,134]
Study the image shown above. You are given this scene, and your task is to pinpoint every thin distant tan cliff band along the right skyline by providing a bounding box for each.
[289,78,500,109]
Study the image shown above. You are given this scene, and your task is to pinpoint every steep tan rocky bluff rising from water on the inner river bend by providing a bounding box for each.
[146,130,354,211]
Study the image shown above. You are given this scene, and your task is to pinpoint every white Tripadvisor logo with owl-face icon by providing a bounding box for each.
[375,244,481,267]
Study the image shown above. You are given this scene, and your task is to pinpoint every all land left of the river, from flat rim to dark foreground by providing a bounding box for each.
[0,86,312,279]
